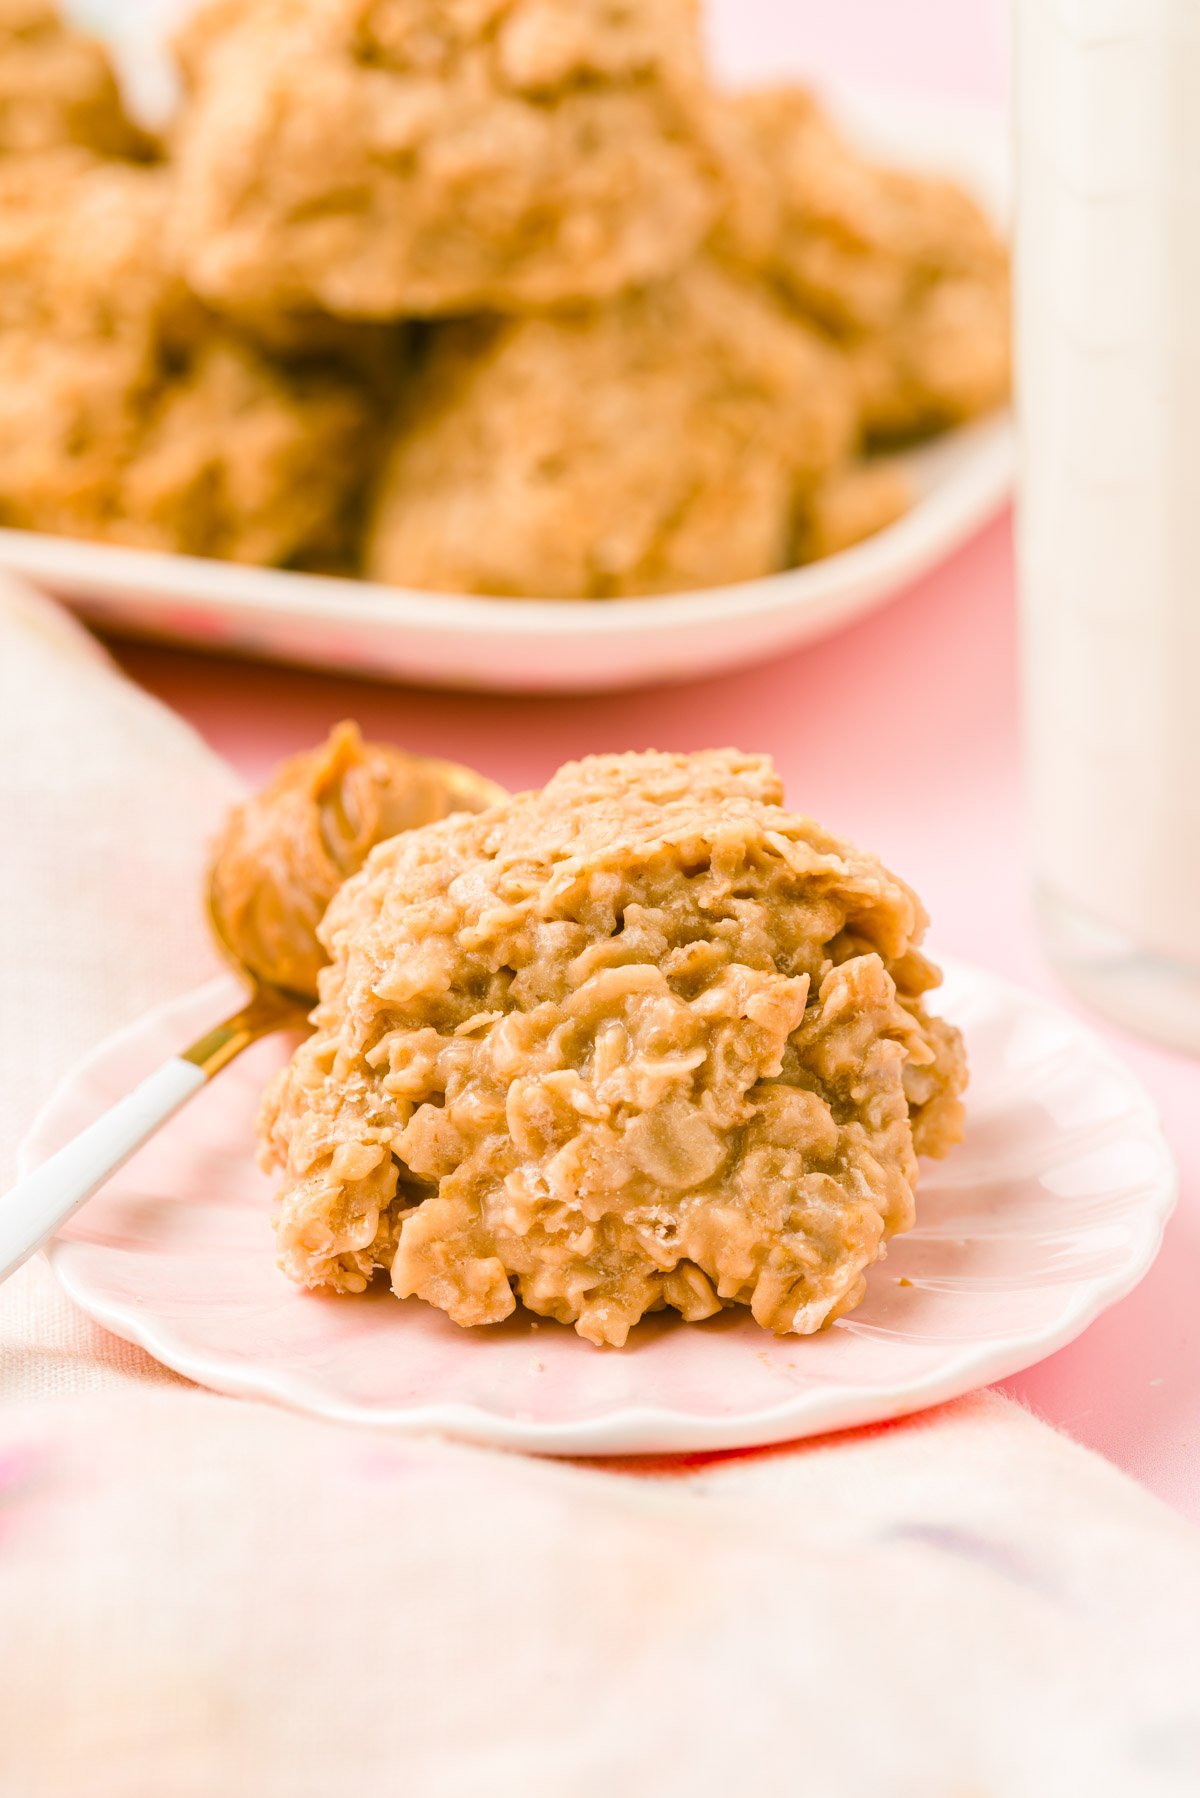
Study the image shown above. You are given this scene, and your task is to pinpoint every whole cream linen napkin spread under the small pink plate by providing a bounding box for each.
[0,588,1200,1798]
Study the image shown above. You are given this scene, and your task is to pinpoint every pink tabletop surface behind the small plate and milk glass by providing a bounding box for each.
[103,0,1200,1519]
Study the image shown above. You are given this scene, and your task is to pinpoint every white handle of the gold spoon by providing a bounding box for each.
[0,1055,205,1280]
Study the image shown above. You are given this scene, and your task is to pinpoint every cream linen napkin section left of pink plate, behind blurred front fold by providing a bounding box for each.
[0,581,239,1399]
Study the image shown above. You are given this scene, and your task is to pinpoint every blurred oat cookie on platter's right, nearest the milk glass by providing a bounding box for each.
[716,88,1011,442]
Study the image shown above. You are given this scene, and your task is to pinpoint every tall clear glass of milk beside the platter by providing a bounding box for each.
[1015,0,1200,1052]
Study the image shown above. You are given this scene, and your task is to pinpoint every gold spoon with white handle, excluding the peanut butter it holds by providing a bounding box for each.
[0,757,507,1280]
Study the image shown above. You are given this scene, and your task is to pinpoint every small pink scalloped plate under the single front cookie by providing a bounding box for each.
[22,966,1175,1455]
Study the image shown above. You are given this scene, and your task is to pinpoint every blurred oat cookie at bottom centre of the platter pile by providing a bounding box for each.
[367,261,856,599]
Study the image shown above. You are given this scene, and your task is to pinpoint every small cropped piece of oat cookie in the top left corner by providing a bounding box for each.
[0,0,153,156]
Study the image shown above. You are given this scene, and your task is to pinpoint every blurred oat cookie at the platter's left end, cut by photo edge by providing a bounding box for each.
[0,149,372,563]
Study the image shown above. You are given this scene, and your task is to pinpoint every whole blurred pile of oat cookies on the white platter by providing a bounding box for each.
[0,0,1009,599]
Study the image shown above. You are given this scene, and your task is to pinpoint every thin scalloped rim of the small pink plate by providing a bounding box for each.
[18,957,1178,1456]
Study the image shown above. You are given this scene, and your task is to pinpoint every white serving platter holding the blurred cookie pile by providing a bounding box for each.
[0,68,1013,692]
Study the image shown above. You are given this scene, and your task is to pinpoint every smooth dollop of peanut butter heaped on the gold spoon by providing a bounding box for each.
[210,723,502,996]
